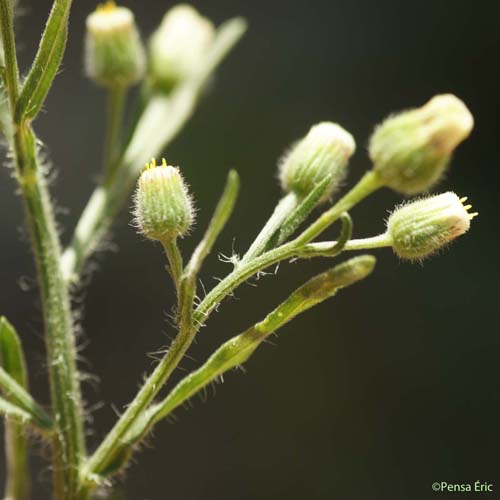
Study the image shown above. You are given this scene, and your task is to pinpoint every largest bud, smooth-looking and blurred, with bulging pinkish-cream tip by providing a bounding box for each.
[369,94,474,194]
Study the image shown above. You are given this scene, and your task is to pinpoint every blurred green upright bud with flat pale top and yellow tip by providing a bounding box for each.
[85,1,146,87]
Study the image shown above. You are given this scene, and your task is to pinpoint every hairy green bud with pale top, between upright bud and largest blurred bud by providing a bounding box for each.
[280,122,356,201]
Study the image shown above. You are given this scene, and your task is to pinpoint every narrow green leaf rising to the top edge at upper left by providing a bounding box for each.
[16,0,71,123]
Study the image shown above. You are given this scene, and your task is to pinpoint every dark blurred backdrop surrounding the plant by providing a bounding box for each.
[0,0,500,500]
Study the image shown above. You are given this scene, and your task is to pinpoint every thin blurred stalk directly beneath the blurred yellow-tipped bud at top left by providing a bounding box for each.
[103,86,126,179]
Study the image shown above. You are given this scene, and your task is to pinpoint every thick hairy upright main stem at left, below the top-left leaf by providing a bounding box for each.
[14,123,85,500]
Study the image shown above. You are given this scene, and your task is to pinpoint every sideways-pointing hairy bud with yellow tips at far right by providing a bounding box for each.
[387,192,477,260]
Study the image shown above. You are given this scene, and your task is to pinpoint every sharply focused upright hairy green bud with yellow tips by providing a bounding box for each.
[134,159,194,242]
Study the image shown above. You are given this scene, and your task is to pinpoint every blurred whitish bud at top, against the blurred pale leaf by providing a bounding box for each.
[149,4,215,91]
